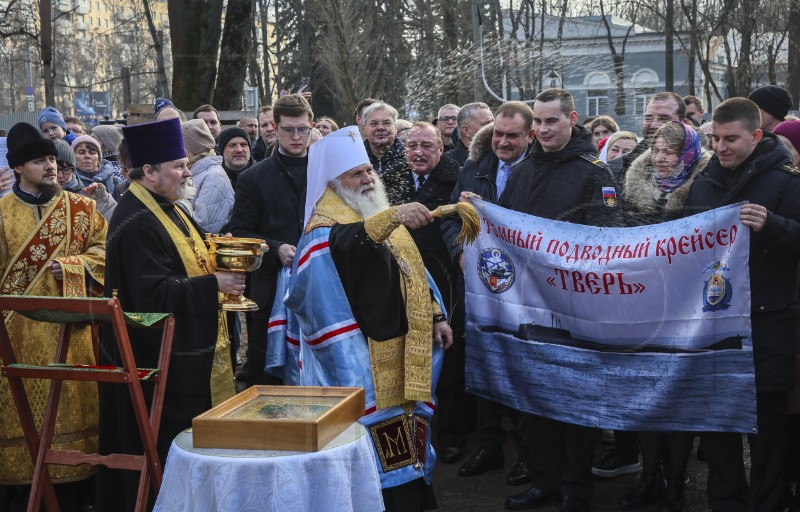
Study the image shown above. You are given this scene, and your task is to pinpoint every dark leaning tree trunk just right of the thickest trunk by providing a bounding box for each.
[214,0,253,110]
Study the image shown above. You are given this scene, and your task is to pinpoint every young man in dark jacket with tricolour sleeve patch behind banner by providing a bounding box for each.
[498,89,622,512]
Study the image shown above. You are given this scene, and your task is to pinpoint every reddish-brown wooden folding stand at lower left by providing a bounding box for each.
[0,295,175,512]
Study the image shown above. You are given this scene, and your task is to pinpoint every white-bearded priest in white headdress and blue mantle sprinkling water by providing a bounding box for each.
[285,127,452,511]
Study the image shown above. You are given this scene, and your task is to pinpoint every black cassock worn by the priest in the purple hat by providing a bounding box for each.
[96,192,219,512]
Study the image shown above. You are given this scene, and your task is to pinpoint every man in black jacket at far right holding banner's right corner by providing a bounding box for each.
[684,98,800,511]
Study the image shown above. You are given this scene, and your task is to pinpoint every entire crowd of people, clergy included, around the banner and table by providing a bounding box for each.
[0,86,800,512]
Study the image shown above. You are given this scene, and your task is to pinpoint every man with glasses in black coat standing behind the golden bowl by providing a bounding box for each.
[229,94,314,386]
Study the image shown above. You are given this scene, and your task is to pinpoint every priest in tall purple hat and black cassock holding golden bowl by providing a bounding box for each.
[96,119,244,511]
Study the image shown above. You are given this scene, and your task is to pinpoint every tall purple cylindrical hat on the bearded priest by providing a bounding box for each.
[122,118,187,168]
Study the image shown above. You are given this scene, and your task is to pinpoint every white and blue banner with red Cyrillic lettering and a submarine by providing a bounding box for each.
[464,201,755,432]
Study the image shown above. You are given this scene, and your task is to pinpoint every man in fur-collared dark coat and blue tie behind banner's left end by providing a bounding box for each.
[442,101,533,485]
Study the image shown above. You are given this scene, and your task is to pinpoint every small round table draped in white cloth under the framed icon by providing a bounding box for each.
[154,423,384,512]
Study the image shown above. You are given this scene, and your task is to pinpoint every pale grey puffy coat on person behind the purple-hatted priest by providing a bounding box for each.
[189,156,233,233]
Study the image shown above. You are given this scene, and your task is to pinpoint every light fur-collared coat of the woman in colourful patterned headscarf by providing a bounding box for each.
[625,145,714,226]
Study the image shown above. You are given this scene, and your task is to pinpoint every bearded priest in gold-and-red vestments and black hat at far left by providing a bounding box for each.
[0,123,107,510]
